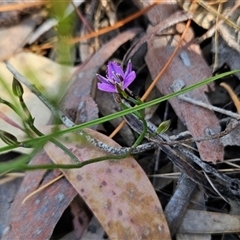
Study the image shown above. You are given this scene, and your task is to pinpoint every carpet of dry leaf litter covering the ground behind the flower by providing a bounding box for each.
[0,0,239,239]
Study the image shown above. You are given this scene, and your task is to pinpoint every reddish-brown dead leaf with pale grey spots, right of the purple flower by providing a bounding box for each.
[146,39,223,162]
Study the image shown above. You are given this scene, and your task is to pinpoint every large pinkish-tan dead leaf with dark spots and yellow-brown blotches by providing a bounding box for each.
[45,126,170,239]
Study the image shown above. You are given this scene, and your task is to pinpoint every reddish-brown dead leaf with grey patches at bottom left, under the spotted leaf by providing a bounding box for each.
[2,153,76,240]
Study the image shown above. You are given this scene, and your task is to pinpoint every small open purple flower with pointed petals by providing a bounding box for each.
[97,61,136,92]
